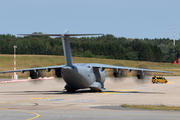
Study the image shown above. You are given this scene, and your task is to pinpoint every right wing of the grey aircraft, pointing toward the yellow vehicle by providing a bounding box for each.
[92,63,173,74]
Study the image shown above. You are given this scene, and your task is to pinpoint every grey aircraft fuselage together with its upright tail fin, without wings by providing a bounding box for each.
[61,30,106,91]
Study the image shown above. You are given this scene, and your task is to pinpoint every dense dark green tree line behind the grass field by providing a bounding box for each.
[0,32,180,62]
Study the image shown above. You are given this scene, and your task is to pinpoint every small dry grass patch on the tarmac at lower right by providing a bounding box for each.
[121,104,180,111]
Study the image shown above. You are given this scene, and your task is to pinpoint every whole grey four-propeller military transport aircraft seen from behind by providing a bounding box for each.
[0,30,172,92]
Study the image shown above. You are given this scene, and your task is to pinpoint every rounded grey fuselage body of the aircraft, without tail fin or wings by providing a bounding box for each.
[61,63,106,90]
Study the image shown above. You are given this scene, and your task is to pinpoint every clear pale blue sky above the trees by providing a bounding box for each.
[0,0,180,39]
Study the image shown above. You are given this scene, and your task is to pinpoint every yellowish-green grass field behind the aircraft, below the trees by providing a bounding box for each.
[0,54,176,78]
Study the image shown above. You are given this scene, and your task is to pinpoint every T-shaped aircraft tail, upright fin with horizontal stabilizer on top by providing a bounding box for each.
[18,30,102,66]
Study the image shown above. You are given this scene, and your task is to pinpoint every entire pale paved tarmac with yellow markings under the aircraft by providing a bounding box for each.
[0,76,180,120]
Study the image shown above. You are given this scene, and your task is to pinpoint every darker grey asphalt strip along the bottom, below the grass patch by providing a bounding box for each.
[0,110,180,120]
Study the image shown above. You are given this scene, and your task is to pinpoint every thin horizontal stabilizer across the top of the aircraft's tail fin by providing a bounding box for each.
[18,34,102,36]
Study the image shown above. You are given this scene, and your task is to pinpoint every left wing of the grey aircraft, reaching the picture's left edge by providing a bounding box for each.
[0,65,65,73]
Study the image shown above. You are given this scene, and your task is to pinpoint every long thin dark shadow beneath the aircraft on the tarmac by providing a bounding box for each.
[0,90,165,95]
